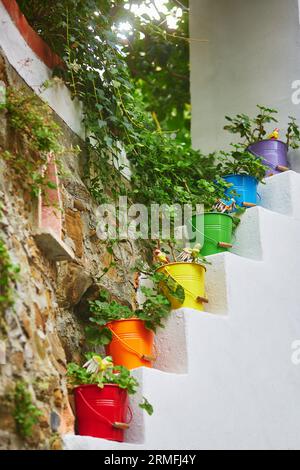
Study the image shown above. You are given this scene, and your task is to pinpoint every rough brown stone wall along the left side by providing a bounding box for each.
[0,55,143,449]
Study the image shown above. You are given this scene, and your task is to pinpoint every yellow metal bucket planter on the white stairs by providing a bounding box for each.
[157,263,208,312]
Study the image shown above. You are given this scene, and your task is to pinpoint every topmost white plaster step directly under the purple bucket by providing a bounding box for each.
[258,171,300,219]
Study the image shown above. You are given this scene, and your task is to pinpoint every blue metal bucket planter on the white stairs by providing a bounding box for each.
[223,175,258,208]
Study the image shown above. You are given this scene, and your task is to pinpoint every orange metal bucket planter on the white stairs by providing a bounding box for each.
[106,318,155,369]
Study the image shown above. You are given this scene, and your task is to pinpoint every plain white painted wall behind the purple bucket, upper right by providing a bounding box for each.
[190,0,300,168]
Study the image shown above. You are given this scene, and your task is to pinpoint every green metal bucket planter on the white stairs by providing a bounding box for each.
[188,212,233,256]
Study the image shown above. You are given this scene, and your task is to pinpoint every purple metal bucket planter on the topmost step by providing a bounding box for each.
[248,139,288,176]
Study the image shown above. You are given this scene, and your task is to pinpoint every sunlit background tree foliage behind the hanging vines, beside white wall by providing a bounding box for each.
[18,0,190,138]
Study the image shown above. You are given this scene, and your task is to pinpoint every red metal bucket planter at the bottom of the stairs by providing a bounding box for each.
[74,384,132,442]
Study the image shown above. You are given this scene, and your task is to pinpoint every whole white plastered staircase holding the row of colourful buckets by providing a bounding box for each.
[64,172,300,450]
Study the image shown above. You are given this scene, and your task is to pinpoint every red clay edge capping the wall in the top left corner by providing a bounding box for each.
[1,0,63,69]
